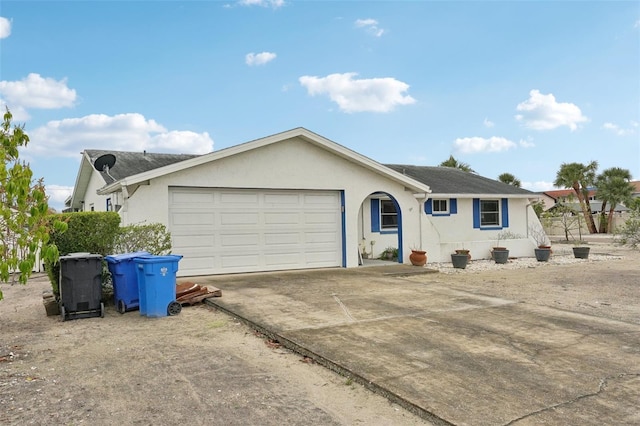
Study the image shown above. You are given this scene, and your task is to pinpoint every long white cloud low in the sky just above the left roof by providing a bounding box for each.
[25,113,213,158]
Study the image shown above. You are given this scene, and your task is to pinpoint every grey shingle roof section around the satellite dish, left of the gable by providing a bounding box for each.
[85,149,198,184]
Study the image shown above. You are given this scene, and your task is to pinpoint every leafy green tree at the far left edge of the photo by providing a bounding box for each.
[0,109,66,300]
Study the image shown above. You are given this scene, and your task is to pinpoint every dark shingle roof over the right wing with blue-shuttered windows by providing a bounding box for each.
[385,164,536,197]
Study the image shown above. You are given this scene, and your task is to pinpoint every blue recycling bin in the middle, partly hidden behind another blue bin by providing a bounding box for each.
[105,251,151,314]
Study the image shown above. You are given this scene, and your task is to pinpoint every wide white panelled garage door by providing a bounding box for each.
[169,187,342,276]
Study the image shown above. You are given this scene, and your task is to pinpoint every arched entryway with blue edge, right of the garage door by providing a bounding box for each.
[358,191,403,265]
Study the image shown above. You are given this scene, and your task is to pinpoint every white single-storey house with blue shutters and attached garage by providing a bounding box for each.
[69,128,540,276]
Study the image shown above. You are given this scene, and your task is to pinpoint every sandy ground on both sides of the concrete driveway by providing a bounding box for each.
[0,243,640,425]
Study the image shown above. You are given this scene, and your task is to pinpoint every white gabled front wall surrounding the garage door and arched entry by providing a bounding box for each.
[116,139,420,267]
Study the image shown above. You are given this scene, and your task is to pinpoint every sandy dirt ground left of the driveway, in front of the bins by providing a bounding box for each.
[0,275,428,425]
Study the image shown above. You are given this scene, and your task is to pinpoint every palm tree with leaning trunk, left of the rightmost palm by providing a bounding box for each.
[553,161,598,234]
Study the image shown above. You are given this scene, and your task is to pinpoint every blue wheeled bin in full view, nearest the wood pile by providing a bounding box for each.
[134,255,182,317]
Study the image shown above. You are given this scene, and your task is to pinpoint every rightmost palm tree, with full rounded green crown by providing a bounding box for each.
[596,167,634,233]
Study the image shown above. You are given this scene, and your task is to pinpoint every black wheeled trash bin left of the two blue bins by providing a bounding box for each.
[59,253,104,321]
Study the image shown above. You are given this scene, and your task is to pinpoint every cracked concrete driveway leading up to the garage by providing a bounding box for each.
[197,265,640,425]
